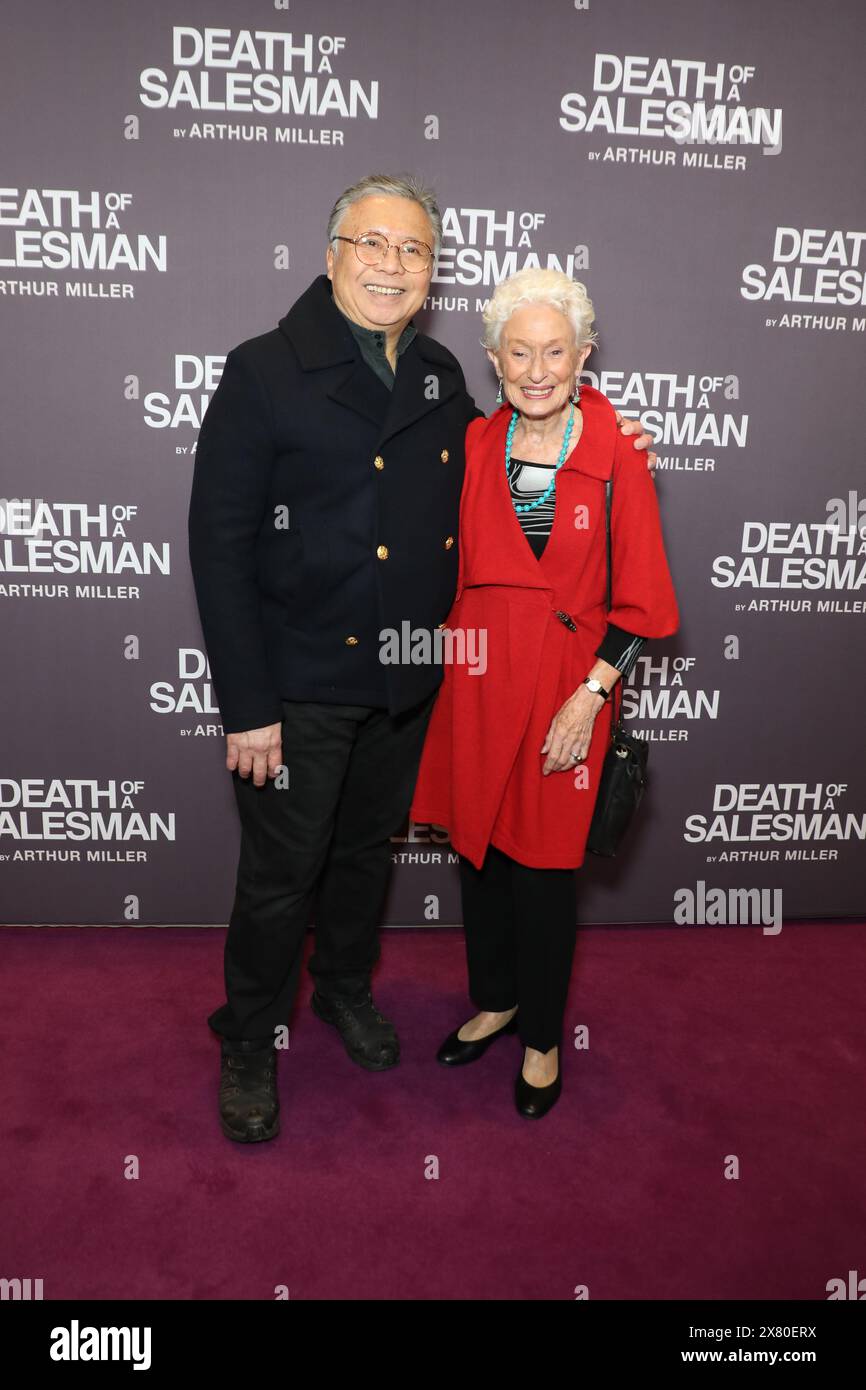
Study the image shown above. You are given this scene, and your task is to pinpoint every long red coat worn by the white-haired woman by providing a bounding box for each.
[411,386,678,869]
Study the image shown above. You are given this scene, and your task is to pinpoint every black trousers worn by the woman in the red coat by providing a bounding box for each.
[460,845,577,1052]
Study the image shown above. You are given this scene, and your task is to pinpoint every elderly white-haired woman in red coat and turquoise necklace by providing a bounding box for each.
[411,270,678,1118]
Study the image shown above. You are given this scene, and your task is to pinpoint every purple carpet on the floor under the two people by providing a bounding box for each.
[0,922,866,1300]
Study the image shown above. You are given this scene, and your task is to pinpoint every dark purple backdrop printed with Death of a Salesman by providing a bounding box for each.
[0,0,866,926]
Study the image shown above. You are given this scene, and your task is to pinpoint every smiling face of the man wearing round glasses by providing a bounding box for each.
[328,193,434,331]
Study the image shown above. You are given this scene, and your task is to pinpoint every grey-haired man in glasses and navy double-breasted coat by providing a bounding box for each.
[189,177,652,1143]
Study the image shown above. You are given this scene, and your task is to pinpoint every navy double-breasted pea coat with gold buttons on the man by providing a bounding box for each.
[189,275,480,733]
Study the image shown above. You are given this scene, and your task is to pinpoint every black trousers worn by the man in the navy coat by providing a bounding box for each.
[209,695,435,1041]
